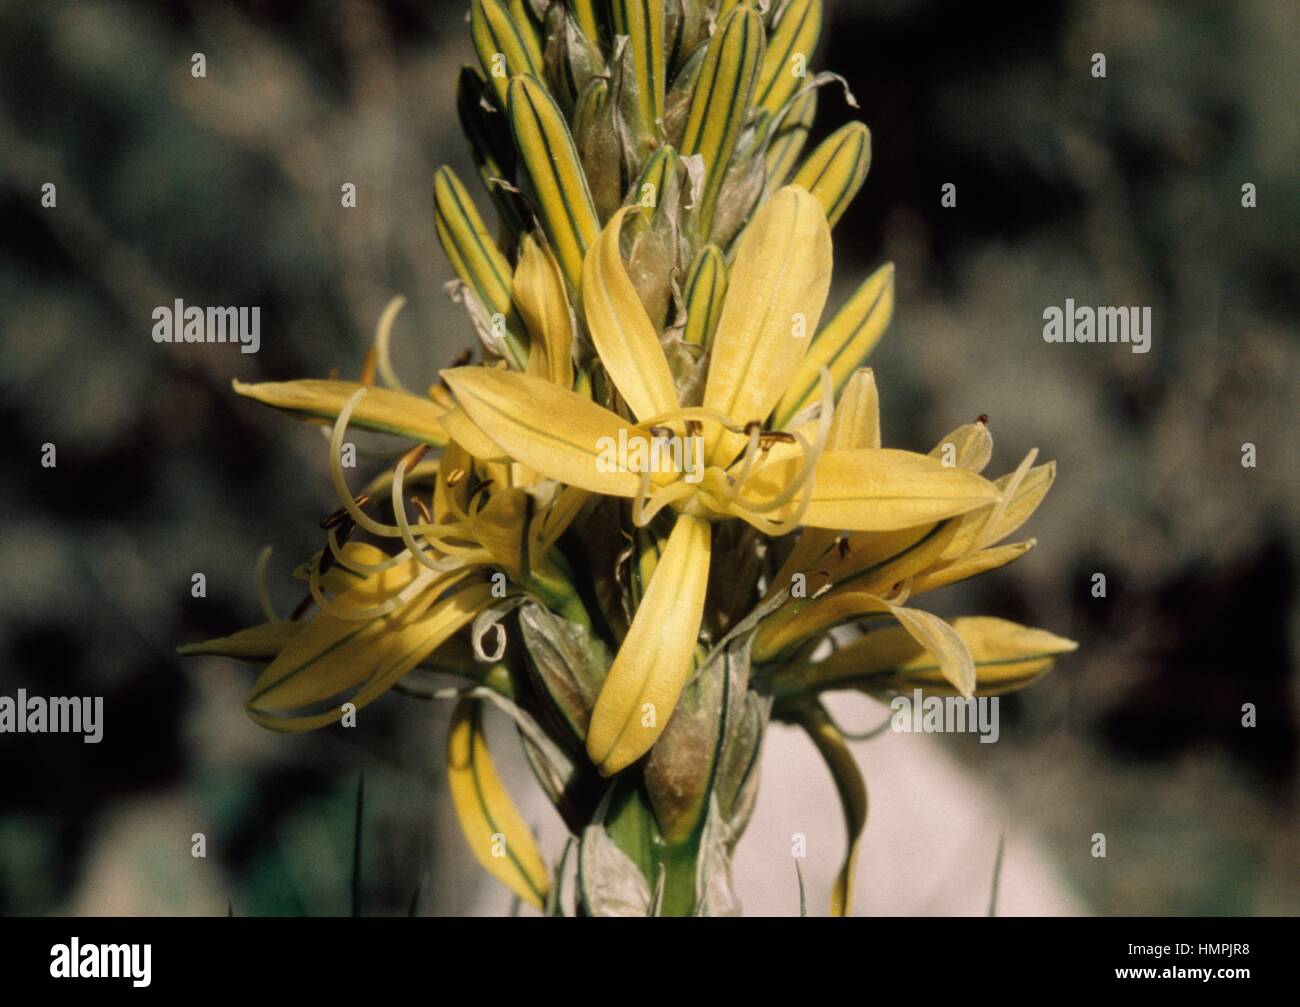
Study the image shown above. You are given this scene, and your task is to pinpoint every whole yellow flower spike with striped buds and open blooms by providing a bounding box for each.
[187,0,1074,915]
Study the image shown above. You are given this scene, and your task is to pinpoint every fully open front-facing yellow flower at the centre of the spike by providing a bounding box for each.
[443,186,1001,774]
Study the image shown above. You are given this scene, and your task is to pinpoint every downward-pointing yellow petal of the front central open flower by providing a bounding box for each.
[586,515,711,776]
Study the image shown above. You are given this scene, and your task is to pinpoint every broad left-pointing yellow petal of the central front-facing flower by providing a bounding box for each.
[442,368,655,496]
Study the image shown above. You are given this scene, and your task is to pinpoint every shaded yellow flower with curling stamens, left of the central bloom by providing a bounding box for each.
[183,382,585,730]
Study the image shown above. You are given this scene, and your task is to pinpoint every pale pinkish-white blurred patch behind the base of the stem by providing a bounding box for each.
[467,694,1088,916]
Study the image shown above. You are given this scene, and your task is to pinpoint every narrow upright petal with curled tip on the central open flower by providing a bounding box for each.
[582,207,677,420]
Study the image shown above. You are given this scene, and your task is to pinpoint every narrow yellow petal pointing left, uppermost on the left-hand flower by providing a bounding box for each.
[231,381,447,447]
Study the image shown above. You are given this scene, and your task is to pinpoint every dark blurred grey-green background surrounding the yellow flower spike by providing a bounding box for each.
[0,0,1300,915]
